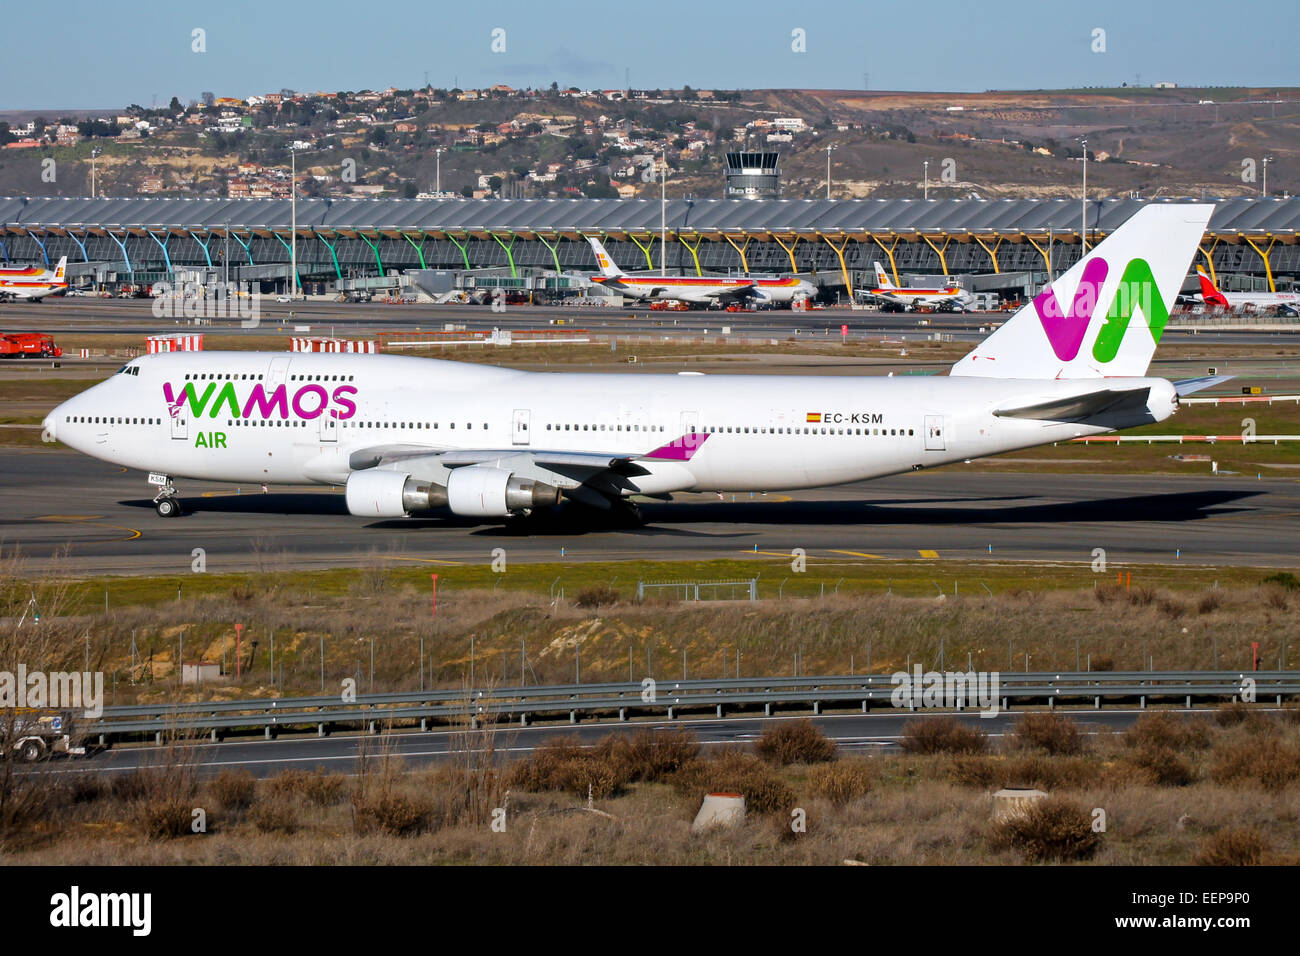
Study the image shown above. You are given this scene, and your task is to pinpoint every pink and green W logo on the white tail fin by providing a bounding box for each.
[1034,256,1169,364]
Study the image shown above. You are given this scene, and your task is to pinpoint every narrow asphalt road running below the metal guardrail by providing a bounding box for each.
[38,706,1170,777]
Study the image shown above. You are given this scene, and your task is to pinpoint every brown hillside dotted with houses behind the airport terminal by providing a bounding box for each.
[0,87,1300,199]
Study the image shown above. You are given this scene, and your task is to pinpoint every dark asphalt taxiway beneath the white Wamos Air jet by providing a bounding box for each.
[0,449,1300,574]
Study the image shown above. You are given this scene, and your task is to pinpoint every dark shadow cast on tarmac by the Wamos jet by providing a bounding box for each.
[120,489,1261,537]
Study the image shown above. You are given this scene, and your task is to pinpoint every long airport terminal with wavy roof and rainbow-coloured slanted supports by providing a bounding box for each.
[0,196,1300,294]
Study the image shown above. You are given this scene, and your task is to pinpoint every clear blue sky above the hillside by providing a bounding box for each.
[0,0,1300,109]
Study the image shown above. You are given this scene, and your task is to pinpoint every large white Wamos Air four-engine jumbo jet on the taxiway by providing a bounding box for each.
[44,203,1213,520]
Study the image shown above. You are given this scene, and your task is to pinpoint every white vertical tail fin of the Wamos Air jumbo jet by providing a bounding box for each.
[952,203,1214,378]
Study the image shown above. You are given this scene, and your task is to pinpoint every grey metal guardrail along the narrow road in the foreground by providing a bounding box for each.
[85,670,1300,743]
